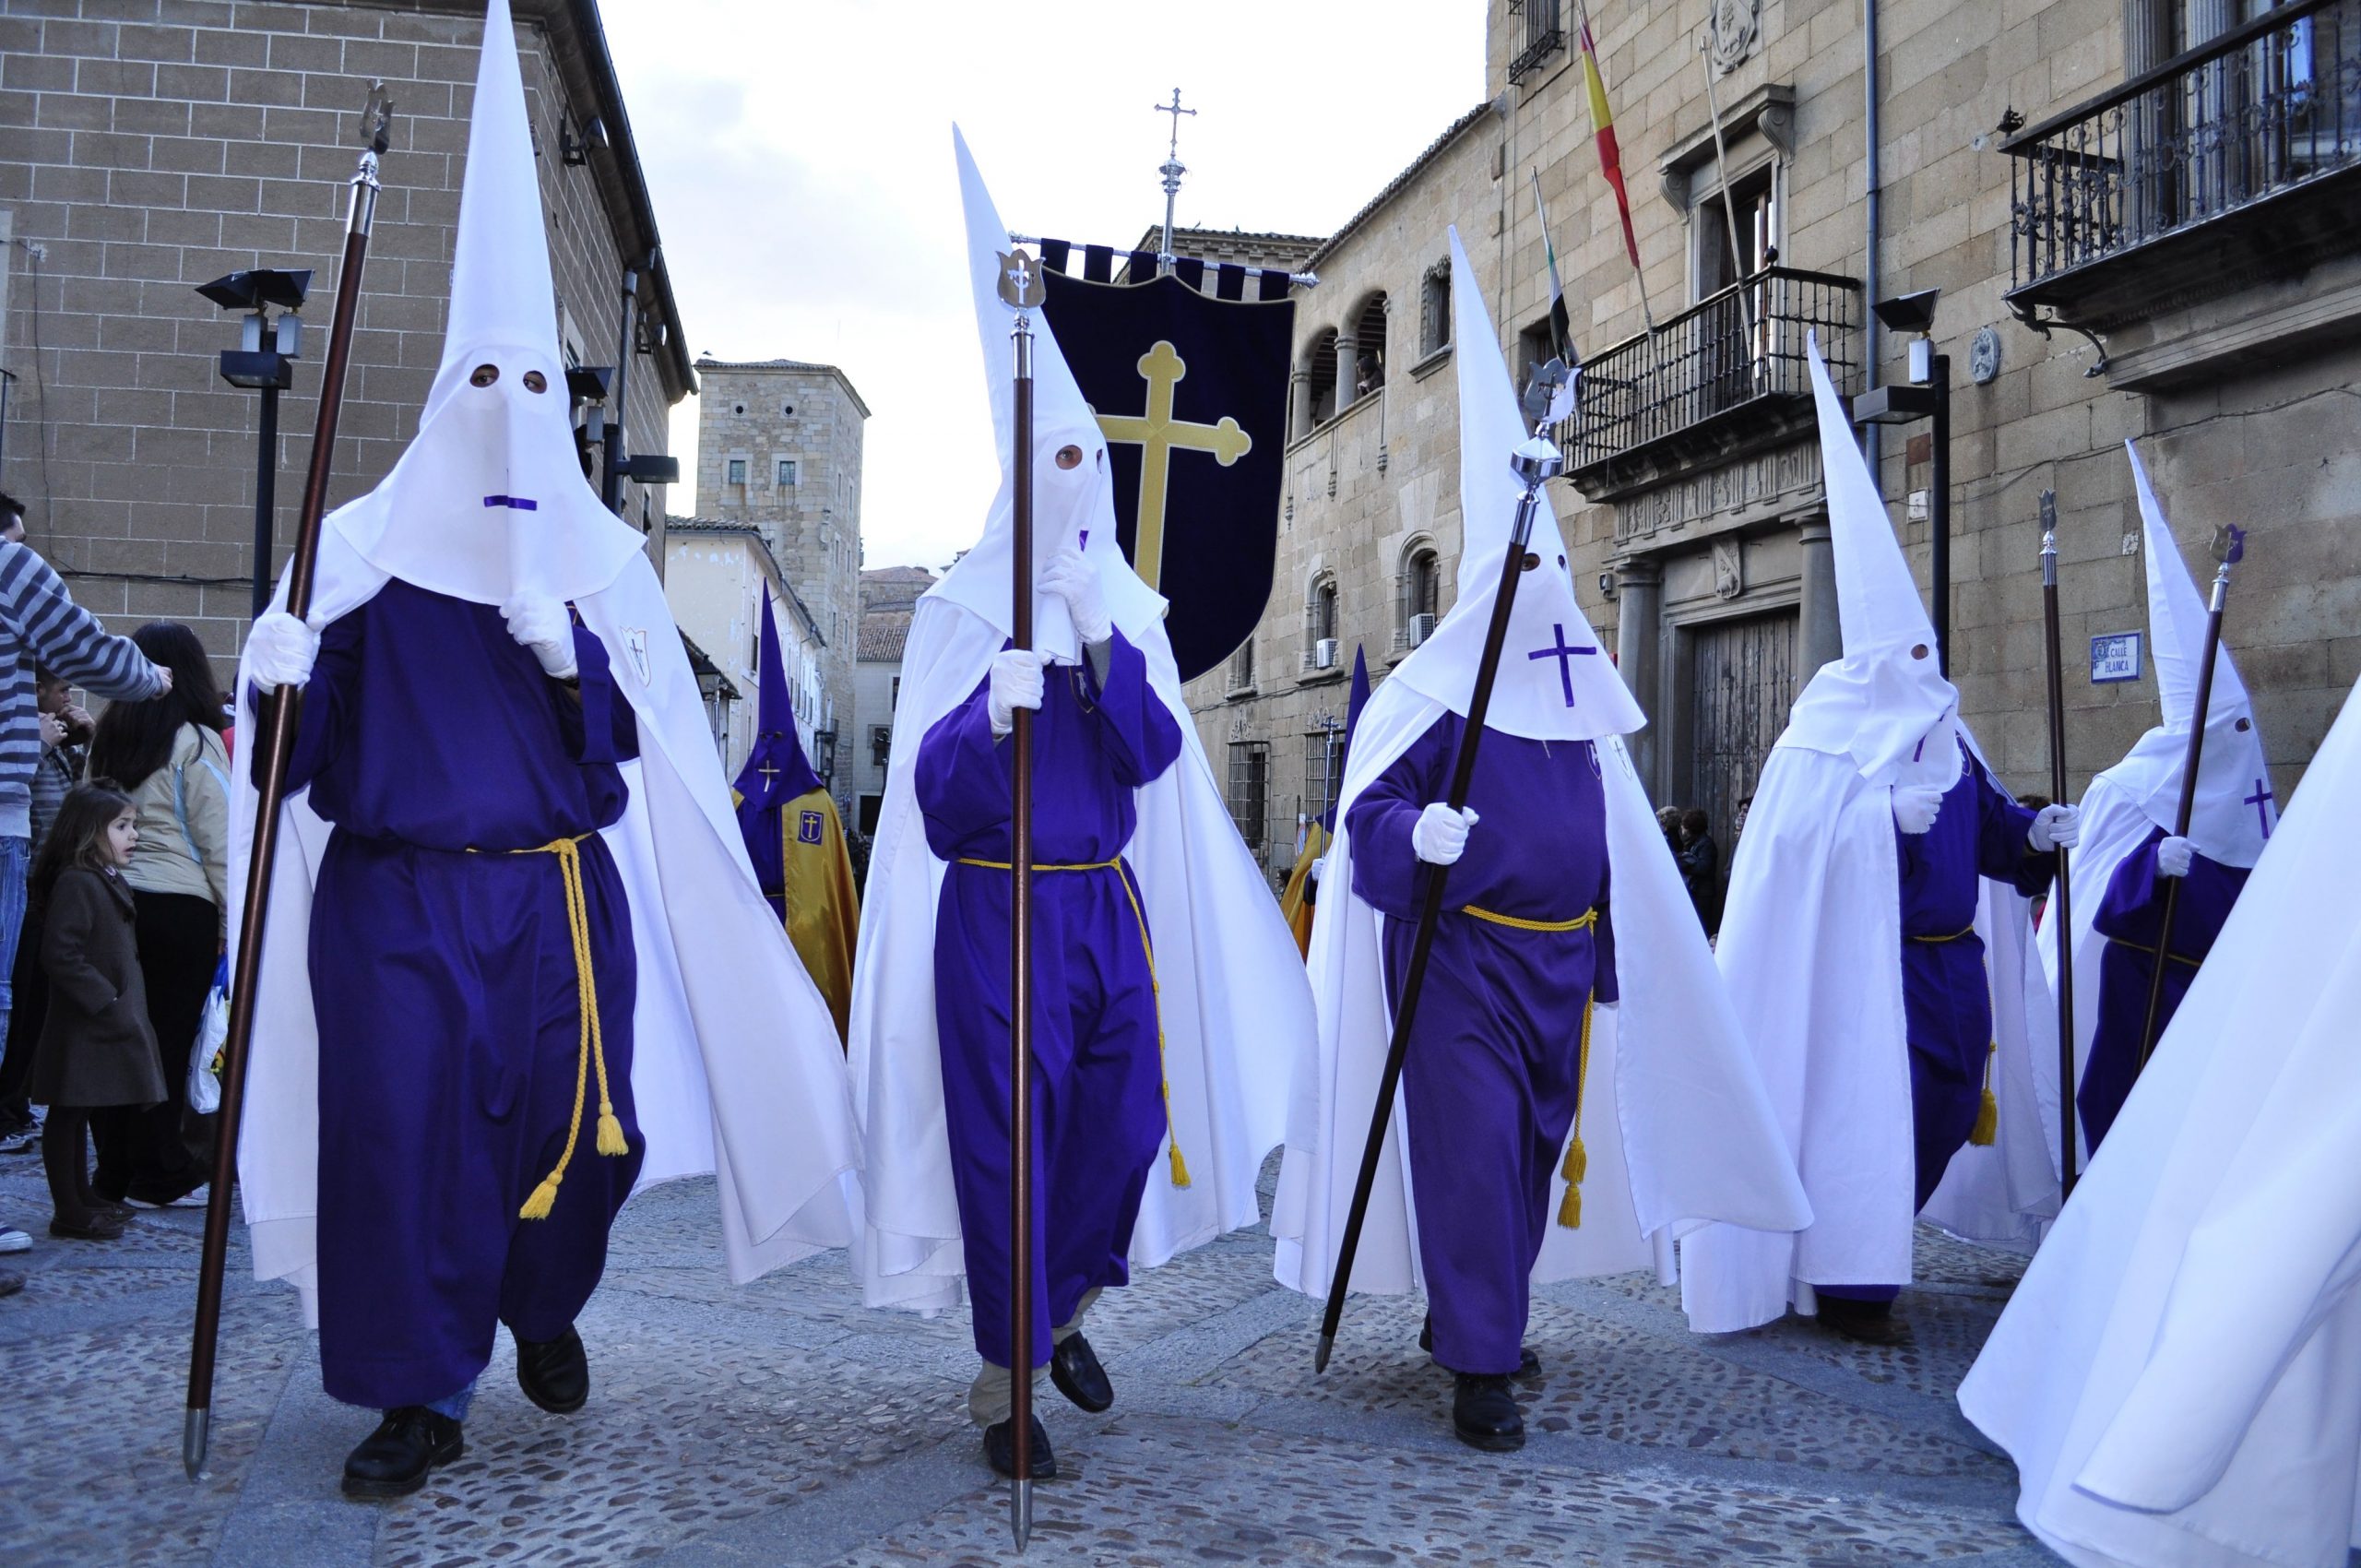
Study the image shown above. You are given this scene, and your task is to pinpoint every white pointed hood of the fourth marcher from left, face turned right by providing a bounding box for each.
[1780,340,1972,787]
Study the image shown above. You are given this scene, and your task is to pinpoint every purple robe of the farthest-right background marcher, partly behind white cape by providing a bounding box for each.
[2075,829,2250,1152]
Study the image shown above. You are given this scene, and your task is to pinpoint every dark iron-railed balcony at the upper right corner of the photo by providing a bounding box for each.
[2002,0,2361,333]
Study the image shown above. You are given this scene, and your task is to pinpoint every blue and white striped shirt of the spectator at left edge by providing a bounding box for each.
[0,543,163,838]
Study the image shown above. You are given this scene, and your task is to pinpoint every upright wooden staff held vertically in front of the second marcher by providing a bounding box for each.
[1001,250,1046,1554]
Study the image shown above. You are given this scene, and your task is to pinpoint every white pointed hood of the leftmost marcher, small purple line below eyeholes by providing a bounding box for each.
[330,0,647,604]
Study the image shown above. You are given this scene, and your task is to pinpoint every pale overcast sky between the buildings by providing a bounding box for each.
[602,0,1485,566]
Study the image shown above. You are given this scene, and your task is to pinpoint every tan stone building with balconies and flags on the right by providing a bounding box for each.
[1190,0,2361,883]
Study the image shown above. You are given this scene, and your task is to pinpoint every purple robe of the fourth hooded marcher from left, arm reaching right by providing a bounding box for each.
[1818,746,2057,1301]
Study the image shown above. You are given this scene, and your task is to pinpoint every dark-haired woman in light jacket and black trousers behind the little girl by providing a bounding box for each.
[89,621,229,1209]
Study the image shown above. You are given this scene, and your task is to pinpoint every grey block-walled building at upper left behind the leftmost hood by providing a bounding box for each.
[0,0,694,657]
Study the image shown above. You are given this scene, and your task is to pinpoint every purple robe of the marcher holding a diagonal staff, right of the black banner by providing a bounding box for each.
[1346,713,1615,1374]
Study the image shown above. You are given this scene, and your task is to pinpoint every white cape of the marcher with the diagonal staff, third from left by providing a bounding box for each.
[1270,680,1811,1297]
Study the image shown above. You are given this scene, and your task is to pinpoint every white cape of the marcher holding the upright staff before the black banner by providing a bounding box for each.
[852,593,1312,1311]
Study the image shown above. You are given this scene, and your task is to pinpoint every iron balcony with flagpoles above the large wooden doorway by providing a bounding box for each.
[1565,267,1860,501]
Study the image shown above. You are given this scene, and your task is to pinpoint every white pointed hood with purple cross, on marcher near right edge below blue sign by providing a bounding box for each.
[2106,442,2278,867]
